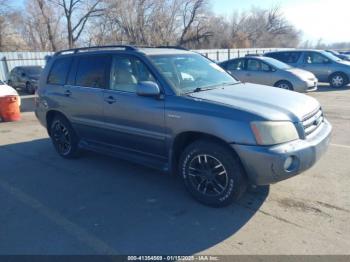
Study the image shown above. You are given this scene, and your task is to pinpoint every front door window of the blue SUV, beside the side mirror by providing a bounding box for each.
[110,57,156,93]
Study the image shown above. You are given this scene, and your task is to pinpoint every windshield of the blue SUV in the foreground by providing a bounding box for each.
[151,54,238,93]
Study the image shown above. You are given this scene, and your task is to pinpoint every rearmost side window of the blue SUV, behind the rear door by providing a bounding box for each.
[47,57,72,85]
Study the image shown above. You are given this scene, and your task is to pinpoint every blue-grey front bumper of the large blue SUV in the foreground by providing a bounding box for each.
[231,120,332,185]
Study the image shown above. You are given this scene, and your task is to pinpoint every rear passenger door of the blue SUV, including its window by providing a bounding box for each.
[63,54,112,142]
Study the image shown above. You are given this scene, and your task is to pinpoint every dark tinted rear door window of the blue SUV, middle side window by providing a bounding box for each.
[75,55,110,88]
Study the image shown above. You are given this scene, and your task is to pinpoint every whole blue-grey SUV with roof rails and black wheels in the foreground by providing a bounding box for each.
[35,46,332,206]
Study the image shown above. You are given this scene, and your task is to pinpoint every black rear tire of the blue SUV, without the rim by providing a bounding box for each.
[50,116,79,159]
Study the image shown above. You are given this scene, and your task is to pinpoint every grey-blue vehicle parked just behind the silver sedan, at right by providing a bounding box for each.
[265,50,350,88]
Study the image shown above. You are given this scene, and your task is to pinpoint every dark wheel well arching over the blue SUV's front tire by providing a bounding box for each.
[171,132,236,173]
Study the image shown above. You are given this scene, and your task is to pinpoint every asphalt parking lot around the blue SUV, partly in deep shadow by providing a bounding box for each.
[0,85,350,254]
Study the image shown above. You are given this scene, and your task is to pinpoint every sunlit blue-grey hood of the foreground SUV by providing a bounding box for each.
[189,83,320,122]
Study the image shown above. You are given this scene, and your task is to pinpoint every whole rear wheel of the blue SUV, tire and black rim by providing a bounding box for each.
[50,115,79,159]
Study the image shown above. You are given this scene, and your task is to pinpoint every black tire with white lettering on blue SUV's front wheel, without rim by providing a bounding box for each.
[179,141,245,207]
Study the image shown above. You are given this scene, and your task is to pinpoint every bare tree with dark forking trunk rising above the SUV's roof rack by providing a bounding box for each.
[51,0,103,48]
